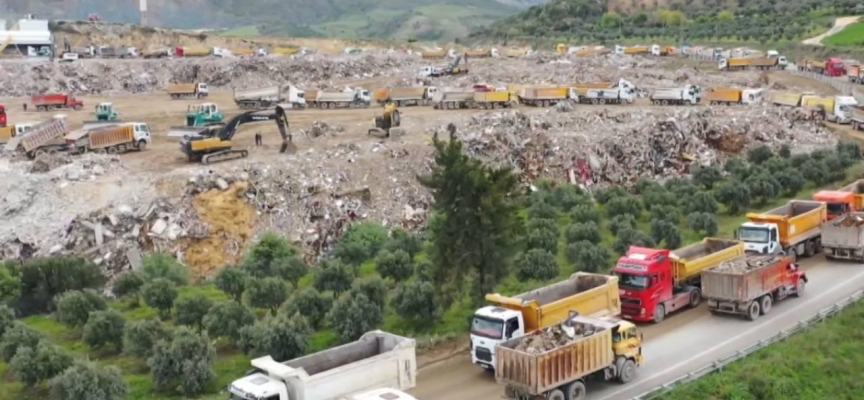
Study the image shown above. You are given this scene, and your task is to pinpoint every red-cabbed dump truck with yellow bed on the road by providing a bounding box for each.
[614,238,744,323]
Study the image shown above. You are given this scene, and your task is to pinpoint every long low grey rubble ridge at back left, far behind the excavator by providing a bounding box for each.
[0,54,419,97]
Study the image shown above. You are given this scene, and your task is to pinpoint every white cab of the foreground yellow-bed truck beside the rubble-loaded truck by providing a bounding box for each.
[470,306,525,371]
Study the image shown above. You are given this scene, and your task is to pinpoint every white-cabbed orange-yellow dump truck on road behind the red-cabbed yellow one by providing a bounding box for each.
[735,200,828,257]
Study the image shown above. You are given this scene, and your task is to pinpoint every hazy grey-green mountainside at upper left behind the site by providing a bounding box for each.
[0,0,544,40]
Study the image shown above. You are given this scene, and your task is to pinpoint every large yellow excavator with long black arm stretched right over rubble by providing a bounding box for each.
[177,104,297,164]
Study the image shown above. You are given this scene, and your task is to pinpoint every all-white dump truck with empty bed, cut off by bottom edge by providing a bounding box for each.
[227,331,417,400]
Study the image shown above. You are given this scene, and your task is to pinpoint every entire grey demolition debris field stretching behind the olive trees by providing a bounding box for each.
[0,54,852,277]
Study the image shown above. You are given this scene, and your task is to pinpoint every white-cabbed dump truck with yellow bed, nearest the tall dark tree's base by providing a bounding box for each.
[471,272,621,370]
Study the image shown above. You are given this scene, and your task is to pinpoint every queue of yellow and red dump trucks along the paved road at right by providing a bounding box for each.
[470,179,864,399]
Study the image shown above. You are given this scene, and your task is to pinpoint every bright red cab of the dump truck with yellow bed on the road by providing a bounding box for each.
[614,246,699,322]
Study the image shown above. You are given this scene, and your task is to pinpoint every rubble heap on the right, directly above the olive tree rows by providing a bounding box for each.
[431,107,837,184]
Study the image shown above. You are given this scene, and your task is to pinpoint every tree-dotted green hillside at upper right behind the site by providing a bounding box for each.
[472,0,864,42]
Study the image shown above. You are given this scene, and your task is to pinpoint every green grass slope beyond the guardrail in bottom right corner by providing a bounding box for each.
[658,294,864,400]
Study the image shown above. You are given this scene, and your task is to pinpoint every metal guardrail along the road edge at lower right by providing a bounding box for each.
[631,289,864,400]
